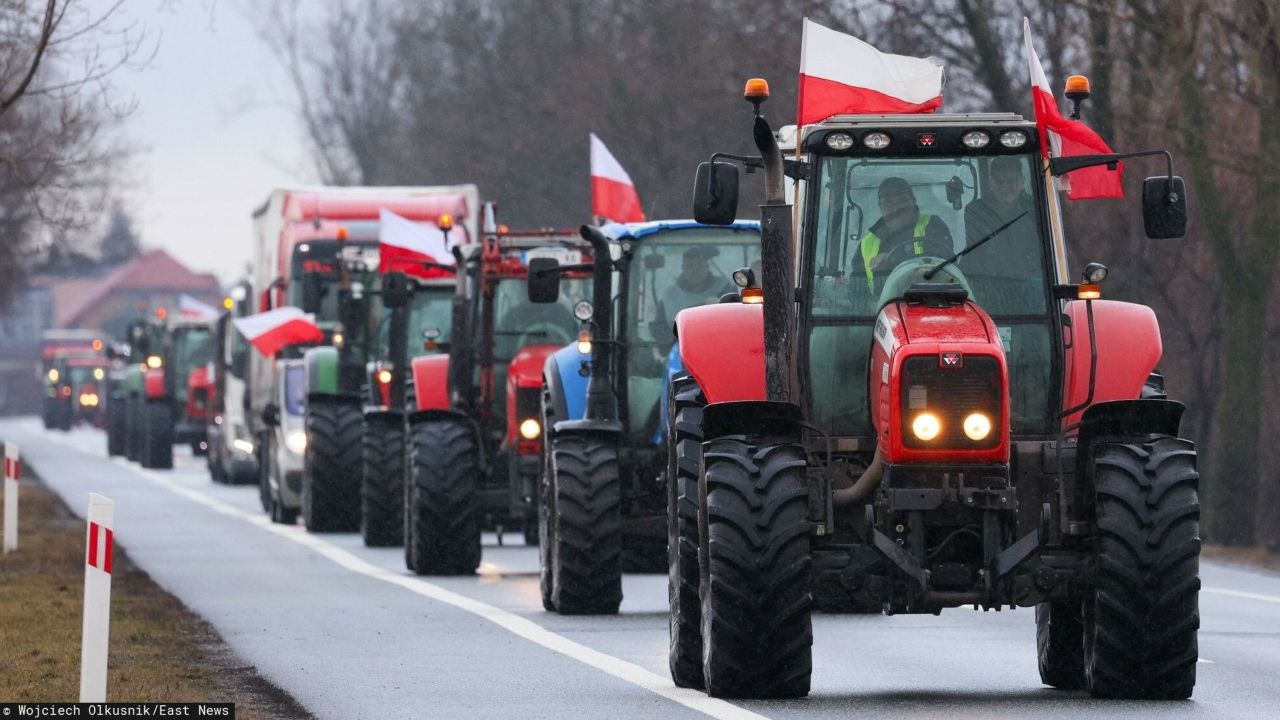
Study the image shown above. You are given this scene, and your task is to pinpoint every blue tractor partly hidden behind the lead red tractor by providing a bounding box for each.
[529,220,760,615]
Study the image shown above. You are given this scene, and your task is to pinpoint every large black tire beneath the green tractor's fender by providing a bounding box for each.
[302,398,364,533]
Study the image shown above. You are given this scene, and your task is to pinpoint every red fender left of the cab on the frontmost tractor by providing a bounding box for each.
[676,302,764,405]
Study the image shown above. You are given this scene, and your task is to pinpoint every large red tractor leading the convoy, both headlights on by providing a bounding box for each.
[669,81,1199,698]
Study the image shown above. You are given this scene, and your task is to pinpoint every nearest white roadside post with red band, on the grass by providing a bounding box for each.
[81,492,115,702]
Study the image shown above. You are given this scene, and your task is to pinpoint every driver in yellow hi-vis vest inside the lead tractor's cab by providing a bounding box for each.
[859,177,952,295]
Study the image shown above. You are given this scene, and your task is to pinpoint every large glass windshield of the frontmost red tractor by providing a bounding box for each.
[804,154,1053,436]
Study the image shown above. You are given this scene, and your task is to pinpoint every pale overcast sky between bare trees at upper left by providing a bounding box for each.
[113,0,319,282]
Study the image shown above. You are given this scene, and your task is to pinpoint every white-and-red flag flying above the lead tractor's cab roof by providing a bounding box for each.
[796,18,942,126]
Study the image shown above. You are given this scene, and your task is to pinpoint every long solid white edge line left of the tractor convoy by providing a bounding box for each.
[104,457,767,720]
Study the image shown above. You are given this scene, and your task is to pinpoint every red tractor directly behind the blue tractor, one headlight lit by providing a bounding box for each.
[404,219,591,575]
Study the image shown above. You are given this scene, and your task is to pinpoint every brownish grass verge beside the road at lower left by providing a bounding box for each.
[0,450,311,719]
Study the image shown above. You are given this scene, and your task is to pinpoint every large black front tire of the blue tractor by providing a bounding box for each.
[550,434,622,615]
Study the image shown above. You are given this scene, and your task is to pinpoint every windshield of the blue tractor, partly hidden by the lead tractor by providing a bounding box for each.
[626,228,760,436]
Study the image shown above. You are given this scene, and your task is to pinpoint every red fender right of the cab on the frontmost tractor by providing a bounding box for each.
[1062,300,1164,425]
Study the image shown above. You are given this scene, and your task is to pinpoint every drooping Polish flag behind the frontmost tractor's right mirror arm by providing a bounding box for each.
[1023,18,1124,200]
